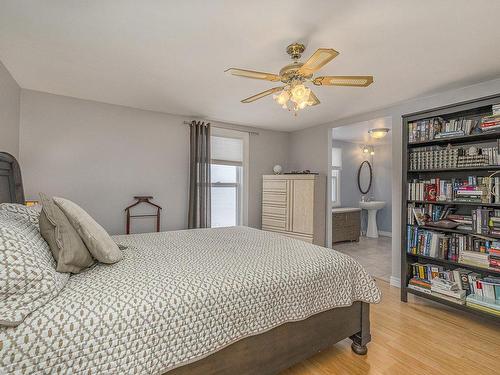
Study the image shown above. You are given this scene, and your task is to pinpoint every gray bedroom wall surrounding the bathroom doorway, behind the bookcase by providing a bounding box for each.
[289,79,500,285]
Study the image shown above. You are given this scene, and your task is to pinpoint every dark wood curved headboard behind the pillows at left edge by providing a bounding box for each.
[0,152,24,204]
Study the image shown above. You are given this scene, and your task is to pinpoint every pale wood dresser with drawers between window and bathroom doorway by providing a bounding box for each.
[262,174,326,246]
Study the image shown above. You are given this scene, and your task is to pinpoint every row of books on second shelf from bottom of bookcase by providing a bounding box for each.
[406,225,500,270]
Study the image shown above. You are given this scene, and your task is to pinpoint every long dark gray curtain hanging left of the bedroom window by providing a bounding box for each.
[188,121,211,229]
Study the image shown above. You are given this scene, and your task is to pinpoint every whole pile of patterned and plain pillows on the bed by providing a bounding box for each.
[0,194,122,326]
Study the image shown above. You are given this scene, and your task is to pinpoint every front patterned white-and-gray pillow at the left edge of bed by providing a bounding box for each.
[0,211,69,326]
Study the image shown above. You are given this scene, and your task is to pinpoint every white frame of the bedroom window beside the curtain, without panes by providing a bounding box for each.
[211,126,250,226]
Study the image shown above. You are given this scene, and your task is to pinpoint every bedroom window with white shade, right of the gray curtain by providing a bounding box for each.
[211,128,248,228]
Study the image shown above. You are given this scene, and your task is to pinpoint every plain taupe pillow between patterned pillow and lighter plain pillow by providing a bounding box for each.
[39,194,94,273]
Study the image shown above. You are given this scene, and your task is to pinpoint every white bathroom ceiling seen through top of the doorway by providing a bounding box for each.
[332,117,392,146]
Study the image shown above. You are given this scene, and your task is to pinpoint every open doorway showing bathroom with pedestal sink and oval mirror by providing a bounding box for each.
[330,117,392,282]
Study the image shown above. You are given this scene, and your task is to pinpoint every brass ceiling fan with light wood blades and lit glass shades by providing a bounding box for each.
[226,43,373,114]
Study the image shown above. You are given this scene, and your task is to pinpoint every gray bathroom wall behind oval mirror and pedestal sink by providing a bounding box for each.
[332,140,392,233]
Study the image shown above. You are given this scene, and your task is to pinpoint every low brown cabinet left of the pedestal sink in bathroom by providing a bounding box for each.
[332,208,361,243]
